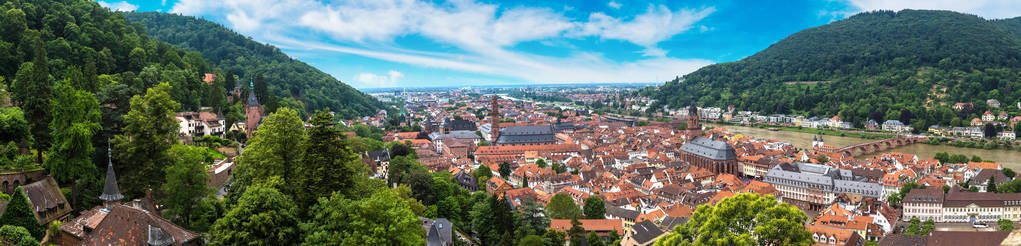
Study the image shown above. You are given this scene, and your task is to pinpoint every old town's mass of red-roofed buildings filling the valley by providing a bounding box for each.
[369,92,1021,245]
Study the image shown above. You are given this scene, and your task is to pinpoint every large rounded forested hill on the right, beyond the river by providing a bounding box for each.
[641,10,1021,129]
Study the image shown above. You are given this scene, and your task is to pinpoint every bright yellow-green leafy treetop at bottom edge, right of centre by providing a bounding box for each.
[655,193,814,245]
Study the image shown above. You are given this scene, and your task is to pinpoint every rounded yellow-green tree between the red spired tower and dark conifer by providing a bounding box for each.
[238,108,305,194]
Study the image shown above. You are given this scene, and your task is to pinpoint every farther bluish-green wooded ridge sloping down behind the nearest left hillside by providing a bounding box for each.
[124,12,382,118]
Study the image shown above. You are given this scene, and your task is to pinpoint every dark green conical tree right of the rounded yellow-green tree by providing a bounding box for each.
[295,111,368,207]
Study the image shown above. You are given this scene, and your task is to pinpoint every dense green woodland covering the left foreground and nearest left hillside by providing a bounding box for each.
[0,0,418,242]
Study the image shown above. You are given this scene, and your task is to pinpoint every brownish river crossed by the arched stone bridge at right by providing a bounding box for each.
[707,124,1021,169]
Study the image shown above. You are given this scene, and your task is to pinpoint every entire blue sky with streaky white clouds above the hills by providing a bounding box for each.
[99,0,1021,88]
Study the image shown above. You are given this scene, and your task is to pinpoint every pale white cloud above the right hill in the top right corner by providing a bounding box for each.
[846,0,1021,18]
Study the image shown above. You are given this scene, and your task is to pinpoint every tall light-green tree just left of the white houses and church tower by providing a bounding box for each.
[113,83,181,197]
